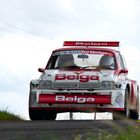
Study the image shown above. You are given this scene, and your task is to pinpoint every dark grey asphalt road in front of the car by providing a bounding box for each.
[0,120,139,140]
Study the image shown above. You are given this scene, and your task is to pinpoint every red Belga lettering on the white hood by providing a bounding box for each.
[55,74,99,82]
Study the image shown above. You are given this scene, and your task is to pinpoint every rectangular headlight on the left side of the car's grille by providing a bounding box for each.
[39,80,52,89]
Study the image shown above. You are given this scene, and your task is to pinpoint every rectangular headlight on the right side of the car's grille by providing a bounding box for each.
[100,81,115,90]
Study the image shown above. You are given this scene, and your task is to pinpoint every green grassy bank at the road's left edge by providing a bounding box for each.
[0,110,23,121]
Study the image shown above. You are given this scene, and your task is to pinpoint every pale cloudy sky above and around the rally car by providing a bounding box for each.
[0,0,140,119]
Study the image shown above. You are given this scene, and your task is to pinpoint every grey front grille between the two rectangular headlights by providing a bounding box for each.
[53,82,100,89]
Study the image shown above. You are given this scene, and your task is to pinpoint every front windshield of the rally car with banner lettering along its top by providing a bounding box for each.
[47,50,115,69]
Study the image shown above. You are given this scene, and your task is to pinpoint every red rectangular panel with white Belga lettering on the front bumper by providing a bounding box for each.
[38,94,111,104]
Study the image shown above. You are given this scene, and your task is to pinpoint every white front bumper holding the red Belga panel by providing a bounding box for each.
[29,90,125,111]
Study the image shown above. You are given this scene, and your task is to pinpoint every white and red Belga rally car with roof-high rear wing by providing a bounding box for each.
[29,41,139,120]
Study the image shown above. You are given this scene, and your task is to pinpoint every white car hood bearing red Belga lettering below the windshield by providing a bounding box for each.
[40,70,115,82]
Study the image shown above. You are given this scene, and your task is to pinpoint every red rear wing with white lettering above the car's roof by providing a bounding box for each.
[63,41,119,47]
